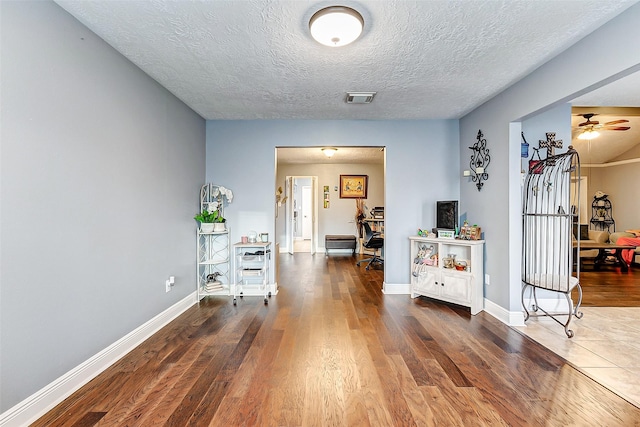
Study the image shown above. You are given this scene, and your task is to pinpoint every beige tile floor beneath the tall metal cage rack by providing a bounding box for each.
[515,307,640,407]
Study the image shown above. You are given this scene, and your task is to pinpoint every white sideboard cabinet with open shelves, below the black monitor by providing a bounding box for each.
[409,236,484,315]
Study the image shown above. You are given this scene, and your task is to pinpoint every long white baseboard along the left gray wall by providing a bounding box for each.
[0,292,197,427]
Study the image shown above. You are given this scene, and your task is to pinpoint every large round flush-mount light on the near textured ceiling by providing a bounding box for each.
[309,6,364,47]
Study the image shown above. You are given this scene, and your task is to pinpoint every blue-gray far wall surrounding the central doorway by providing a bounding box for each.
[207,120,460,284]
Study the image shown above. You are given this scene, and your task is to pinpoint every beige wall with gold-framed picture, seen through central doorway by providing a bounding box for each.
[276,163,384,250]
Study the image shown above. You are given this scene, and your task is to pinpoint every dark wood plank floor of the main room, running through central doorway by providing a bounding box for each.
[34,253,640,426]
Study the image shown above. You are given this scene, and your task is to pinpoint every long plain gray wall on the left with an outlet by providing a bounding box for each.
[0,1,205,412]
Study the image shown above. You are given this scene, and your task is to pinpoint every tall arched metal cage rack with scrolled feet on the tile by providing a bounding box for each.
[522,147,582,338]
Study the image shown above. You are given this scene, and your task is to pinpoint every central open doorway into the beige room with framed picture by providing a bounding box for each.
[274,146,385,256]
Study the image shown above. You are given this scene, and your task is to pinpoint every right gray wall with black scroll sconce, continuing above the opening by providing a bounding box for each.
[460,5,640,312]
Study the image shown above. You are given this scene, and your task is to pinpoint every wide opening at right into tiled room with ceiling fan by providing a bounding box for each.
[518,83,640,405]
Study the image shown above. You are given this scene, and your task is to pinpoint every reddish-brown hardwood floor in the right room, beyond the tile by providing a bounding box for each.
[573,260,640,307]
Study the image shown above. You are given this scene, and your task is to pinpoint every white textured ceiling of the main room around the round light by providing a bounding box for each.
[56,0,637,120]
